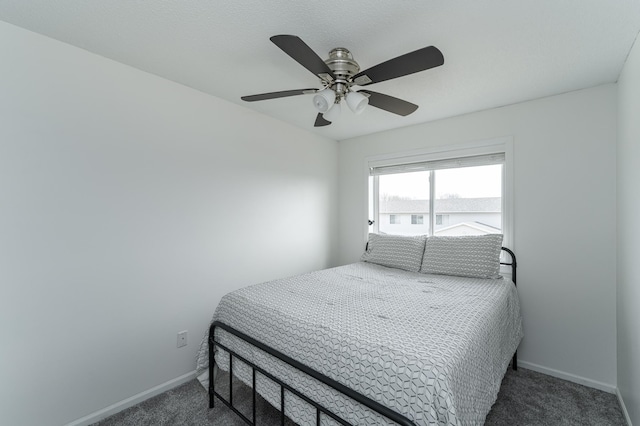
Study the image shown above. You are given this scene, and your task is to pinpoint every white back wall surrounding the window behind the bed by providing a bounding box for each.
[339,85,620,391]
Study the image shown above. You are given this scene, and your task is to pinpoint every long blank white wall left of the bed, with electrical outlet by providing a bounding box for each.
[0,22,338,426]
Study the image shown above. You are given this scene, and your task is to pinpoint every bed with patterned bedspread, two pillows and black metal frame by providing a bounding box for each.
[197,235,523,425]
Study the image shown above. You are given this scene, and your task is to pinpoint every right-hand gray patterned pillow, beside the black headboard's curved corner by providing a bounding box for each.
[420,234,502,279]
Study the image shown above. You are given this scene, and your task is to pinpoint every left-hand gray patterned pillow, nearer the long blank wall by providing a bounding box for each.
[360,234,427,272]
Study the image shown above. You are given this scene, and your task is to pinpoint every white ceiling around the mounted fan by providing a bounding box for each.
[0,0,640,140]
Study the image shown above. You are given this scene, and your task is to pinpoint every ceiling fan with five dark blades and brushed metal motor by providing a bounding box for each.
[241,35,444,127]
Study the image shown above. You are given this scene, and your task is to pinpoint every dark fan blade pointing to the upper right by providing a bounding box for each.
[353,46,444,86]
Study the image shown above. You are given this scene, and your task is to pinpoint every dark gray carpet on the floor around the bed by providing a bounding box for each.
[95,368,626,426]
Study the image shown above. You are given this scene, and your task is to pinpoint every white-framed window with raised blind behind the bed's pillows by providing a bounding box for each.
[368,138,513,247]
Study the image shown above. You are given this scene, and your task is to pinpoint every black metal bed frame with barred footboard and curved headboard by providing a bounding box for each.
[209,247,518,426]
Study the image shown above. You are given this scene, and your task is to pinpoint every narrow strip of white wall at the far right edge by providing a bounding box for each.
[617,31,640,425]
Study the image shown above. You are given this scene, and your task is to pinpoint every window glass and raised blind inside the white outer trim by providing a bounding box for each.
[369,155,504,235]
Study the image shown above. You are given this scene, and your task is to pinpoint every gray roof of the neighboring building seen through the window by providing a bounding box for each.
[379,197,502,214]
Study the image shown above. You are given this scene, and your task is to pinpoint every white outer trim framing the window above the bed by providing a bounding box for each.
[362,136,515,250]
